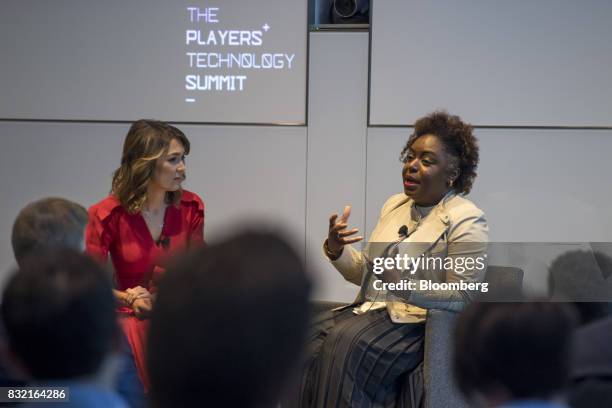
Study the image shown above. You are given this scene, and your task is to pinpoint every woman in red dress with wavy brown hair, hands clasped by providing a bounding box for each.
[85,120,204,391]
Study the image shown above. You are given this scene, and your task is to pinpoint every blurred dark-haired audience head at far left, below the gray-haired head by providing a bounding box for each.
[1,249,118,380]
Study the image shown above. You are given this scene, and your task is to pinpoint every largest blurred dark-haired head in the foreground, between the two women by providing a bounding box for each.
[148,232,311,407]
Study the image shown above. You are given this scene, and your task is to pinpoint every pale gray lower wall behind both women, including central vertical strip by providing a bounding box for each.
[0,32,612,300]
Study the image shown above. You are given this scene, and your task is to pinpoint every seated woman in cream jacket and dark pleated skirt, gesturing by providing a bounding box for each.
[300,112,488,407]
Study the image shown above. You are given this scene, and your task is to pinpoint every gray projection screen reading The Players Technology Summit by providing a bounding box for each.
[0,0,307,125]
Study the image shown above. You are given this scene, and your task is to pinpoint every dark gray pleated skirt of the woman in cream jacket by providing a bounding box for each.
[299,307,425,408]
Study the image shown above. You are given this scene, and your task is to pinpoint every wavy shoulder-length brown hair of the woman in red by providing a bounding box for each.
[111,119,189,213]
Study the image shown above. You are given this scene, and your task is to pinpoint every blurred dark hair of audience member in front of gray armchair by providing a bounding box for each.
[453,302,575,399]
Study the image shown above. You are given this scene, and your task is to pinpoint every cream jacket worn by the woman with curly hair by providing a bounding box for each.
[330,192,489,323]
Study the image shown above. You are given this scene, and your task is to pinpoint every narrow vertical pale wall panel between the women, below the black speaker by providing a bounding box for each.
[306,32,368,301]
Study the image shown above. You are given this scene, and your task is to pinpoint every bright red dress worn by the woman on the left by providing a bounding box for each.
[85,190,204,391]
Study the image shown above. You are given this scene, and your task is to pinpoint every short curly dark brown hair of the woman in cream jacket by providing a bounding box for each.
[400,111,479,194]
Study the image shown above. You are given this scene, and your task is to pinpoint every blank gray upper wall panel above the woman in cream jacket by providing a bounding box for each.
[369,0,612,127]
